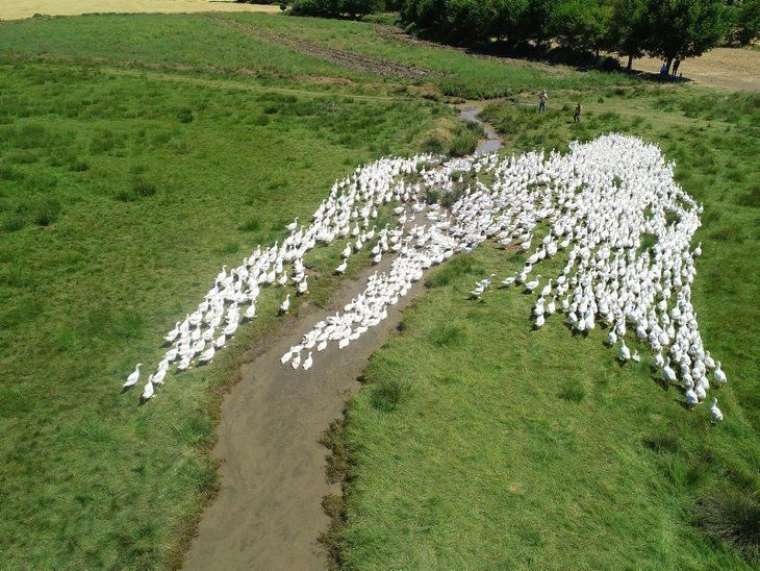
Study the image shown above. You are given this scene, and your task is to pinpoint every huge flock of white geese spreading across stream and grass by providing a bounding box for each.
[124,135,727,421]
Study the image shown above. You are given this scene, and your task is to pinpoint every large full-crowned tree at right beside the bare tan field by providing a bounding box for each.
[645,0,728,73]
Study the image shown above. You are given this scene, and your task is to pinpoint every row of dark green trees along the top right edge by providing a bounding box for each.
[284,0,760,73]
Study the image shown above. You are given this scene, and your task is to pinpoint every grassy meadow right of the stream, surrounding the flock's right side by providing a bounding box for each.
[338,88,760,570]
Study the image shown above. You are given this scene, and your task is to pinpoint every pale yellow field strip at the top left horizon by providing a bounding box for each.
[0,0,280,20]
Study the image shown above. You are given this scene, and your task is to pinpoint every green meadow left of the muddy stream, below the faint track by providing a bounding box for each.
[0,32,452,569]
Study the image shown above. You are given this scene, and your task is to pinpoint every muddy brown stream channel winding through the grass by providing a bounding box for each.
[184,106,501,571]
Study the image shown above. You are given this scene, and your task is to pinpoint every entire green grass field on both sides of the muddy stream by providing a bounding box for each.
[0,10,760,569]
